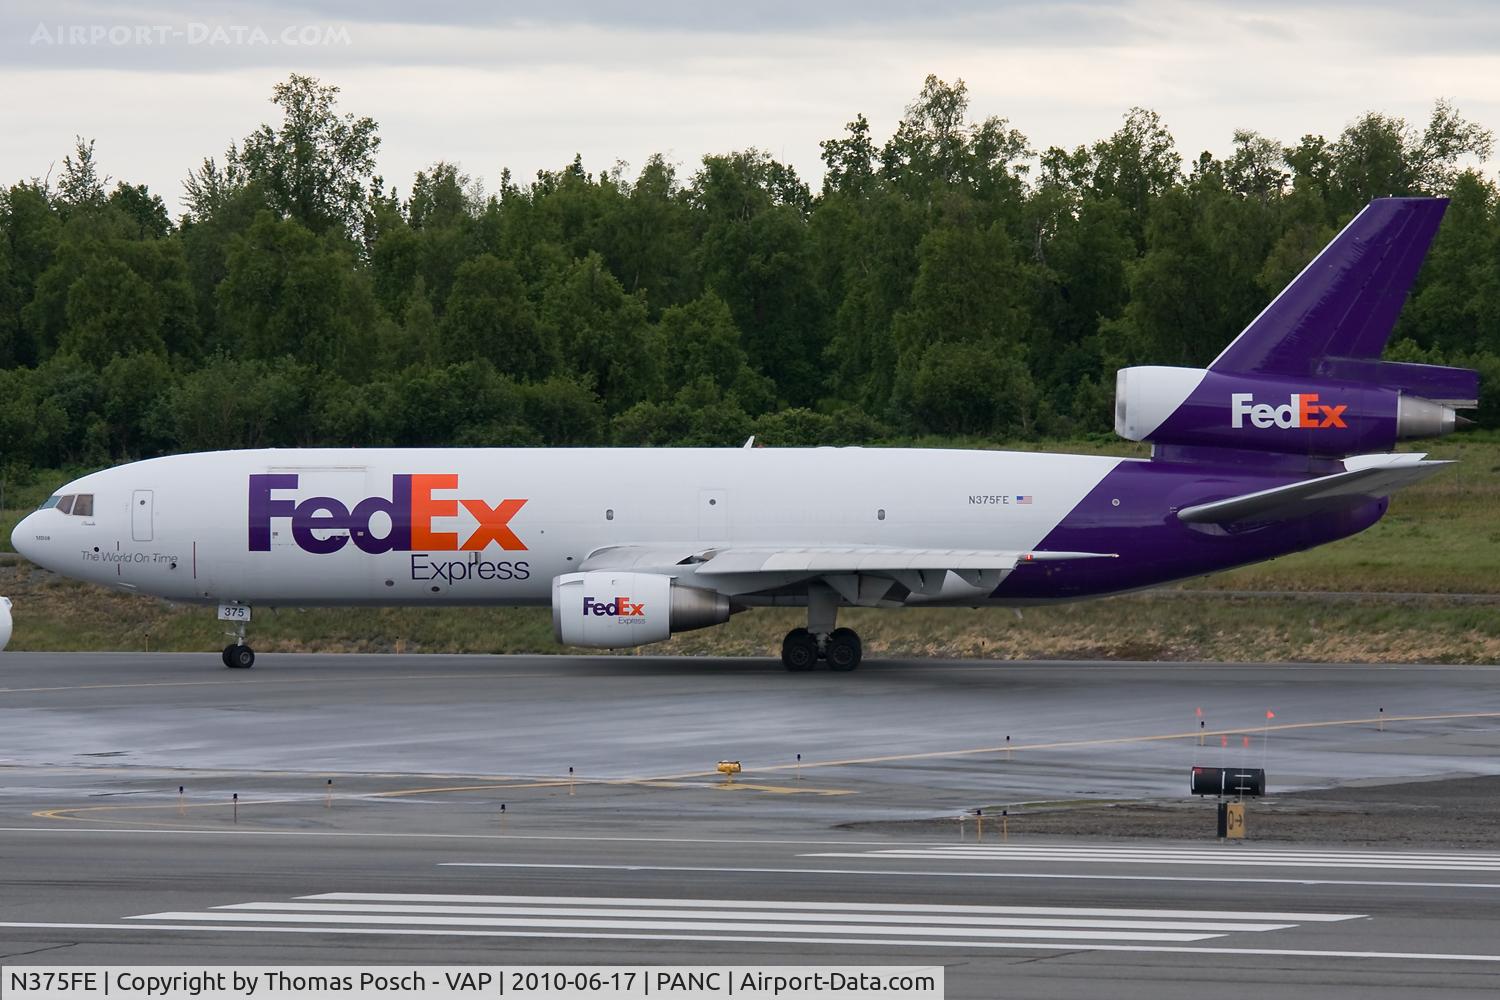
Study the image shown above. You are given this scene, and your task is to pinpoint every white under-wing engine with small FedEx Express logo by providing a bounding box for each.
[552,570,731,649]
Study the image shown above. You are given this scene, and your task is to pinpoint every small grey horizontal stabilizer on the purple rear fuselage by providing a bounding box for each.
[1178,454,1452,525]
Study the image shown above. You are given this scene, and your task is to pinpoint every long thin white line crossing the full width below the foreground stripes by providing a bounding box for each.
[0,921,1500,963]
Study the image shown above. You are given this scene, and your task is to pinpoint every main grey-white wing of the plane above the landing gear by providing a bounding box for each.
[579,544,1115,606]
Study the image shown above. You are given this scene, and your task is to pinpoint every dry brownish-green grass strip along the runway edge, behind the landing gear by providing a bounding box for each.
[0,556,1500,663]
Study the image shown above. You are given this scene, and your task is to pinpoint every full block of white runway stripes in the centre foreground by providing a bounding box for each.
[126,892,1362,949]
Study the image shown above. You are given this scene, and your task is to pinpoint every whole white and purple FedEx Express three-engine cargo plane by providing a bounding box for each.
[14,198,1479,670]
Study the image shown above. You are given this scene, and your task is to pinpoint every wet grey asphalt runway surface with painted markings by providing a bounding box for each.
[0,654,1500,997]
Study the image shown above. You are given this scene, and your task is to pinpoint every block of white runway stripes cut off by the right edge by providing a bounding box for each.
[800,844,1500,871]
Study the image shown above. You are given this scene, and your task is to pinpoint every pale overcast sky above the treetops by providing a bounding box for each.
[0,0,1500,213]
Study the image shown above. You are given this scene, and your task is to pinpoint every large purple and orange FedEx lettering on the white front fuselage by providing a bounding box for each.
[249,472,527,555]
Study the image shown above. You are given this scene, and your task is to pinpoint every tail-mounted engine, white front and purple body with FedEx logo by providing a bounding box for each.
[1115,366,1458,456]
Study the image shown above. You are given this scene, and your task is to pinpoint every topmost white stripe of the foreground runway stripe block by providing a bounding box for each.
[313,892,1365,924]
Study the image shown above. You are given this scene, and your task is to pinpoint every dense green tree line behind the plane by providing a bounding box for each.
[0,75,1500,469]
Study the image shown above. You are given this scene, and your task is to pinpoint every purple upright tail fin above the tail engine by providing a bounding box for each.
[1209,198,1448,375]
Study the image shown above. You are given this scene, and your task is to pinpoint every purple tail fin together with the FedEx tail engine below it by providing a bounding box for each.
[1115,198,1479,462]
